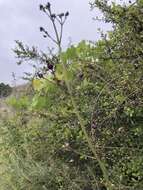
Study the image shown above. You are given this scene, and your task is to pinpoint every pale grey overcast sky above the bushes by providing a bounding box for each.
[0,0,111,84]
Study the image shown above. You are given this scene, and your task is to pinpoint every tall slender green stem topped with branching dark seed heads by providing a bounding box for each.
[39,2,113,190]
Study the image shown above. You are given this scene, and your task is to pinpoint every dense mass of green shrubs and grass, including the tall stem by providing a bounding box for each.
[0,0,143,190]
